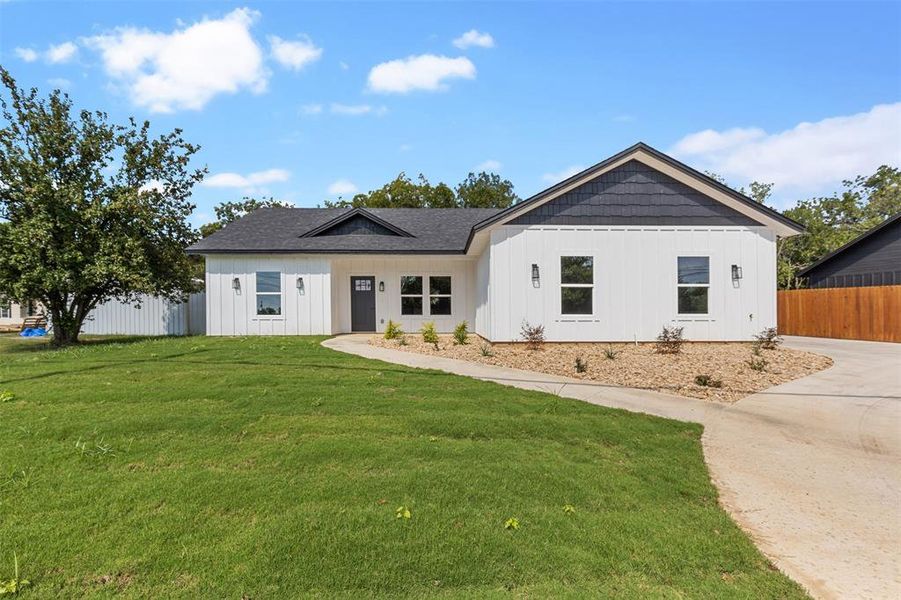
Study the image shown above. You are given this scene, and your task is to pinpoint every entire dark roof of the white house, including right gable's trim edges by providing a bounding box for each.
[188,142,804,254]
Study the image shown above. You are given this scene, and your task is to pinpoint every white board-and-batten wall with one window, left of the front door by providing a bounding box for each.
[206,254,332,335]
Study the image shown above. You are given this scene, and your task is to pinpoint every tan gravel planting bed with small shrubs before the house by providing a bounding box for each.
[370,334,832,403]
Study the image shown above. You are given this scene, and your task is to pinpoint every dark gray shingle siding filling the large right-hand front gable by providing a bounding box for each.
[510,160,761,226]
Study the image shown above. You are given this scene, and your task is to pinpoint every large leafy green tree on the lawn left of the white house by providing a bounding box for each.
[0,67,205,345]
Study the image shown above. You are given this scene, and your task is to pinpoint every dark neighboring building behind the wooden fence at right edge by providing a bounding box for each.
[798,213,901,288]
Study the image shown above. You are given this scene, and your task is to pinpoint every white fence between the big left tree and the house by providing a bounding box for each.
[81,292,206,335]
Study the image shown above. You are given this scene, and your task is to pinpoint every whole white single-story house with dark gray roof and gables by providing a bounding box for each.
[188,144,802,342]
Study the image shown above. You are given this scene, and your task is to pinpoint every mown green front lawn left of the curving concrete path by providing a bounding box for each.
[0,337,803,599]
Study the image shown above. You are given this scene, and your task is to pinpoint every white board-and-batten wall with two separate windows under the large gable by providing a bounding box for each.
[488,225,776,342]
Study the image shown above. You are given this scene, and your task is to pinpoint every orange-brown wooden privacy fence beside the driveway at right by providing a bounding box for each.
[777,285,901,342]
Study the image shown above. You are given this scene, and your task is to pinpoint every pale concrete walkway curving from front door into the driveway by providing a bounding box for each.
[324,335,901,598]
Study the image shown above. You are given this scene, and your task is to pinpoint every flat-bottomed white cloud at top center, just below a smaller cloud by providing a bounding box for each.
[369,54,476,94]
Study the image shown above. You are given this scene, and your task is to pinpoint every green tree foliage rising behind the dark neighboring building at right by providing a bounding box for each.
[778,165,901,288]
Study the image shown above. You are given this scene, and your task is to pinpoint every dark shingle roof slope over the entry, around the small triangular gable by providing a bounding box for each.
[188,208,500,254]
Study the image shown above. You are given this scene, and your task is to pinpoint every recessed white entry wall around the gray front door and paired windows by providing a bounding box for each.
[332,255,476,333]
